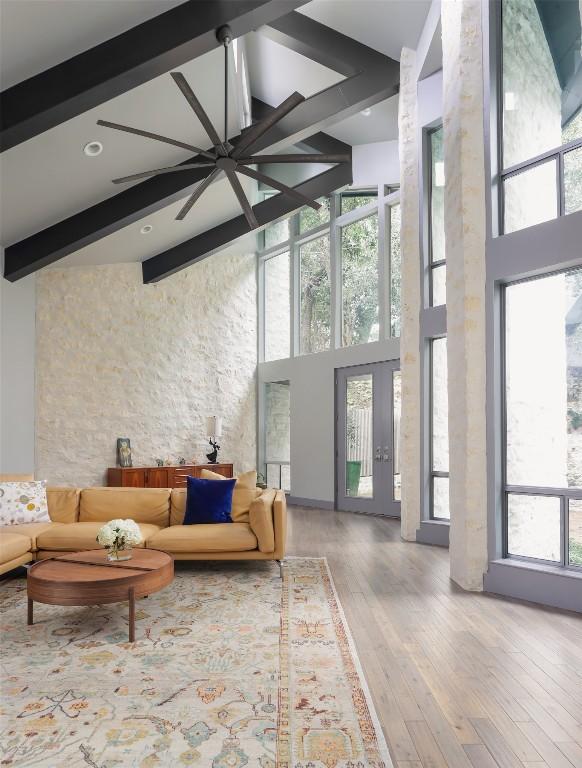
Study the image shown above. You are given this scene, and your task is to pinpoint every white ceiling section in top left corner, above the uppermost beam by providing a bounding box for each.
[0,0,184,90]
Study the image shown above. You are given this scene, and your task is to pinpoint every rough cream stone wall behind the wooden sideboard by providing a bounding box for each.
[36,254,257,485]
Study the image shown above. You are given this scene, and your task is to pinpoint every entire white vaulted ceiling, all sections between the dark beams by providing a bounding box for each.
[0,0,438,266]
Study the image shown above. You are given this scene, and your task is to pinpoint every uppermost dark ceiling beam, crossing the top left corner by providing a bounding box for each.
[0,0,307,151]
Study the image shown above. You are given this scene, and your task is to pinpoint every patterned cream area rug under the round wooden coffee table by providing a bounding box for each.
[0,558,392,768]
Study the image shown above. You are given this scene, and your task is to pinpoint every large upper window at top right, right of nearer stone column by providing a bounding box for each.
[499,0,582,233]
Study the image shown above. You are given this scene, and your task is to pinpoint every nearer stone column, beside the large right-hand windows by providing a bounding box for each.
[442,0,487,590]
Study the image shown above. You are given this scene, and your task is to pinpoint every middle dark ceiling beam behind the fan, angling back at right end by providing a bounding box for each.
[4,12,399,281]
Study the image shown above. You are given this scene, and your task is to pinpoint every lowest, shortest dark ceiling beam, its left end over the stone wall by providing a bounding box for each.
[142,133,352,283]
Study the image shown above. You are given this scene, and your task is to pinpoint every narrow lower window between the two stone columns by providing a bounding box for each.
[430,337,451,520]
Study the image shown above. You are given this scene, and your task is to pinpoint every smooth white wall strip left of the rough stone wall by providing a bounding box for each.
[0,251,35,474]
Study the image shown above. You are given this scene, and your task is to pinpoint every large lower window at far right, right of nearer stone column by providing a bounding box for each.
[504,269,582,567]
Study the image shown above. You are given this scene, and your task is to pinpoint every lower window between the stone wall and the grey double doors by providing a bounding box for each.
[264,381,291,491]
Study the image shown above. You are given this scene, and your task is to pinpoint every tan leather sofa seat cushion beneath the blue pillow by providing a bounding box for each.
[147,523,257,552]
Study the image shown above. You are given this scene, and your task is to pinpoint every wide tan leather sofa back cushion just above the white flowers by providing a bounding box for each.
[79,488,170,527]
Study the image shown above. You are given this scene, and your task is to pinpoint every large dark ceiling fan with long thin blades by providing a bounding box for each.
[97,25,351,229]
